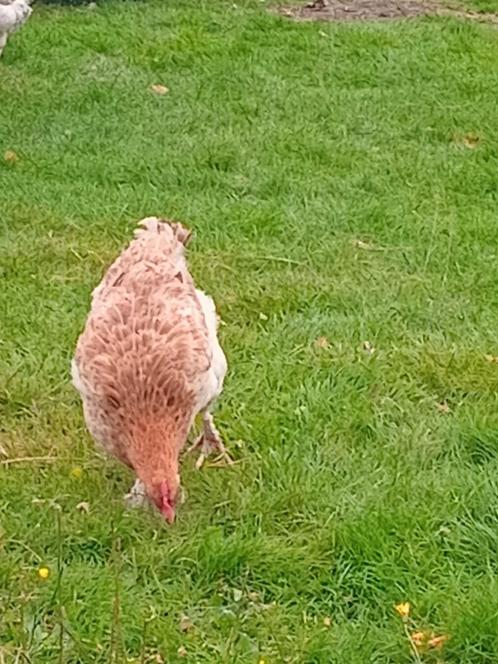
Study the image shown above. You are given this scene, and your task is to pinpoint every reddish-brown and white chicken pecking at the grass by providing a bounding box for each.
[72,217,231,523]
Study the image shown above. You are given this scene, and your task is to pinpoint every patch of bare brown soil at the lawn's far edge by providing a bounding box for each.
[278,0,498,23]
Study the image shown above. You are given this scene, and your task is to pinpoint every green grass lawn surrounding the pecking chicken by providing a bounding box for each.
[0,0,498,664]
